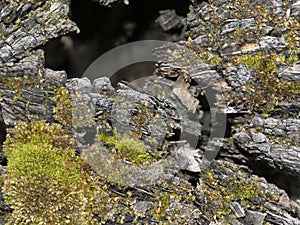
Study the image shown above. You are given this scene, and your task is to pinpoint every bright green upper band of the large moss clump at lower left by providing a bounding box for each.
[7,140,81,185]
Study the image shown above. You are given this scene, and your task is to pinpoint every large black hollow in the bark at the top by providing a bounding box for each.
[43,0,190,78]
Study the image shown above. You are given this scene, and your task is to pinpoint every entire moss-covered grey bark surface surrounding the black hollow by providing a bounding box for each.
[0,0,300,225]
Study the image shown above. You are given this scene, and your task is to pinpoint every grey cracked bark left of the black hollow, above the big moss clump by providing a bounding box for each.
[0,1,78,125]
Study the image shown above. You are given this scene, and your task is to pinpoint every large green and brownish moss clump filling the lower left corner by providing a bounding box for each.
[3,121,98,224]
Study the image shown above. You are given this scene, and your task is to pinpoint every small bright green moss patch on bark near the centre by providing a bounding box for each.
[99,131,157,166]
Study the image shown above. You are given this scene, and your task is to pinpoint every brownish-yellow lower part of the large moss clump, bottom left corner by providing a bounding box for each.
[3,174,95,225]
